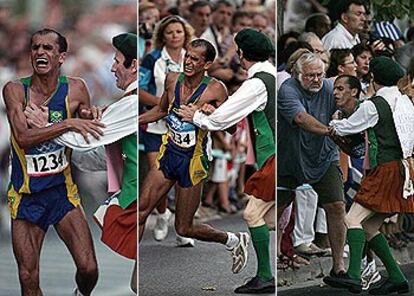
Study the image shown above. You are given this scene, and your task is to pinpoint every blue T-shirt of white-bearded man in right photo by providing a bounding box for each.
[277,78,339,184]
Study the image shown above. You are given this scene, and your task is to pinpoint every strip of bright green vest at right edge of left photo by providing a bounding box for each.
[118,134,138,209]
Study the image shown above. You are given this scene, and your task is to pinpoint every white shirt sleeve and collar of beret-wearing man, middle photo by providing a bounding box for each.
[193,61,276,131]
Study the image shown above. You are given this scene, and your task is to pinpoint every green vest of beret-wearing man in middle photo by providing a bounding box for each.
[249,72,276,168]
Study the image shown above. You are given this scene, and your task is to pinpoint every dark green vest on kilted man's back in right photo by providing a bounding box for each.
[368,96,403,168]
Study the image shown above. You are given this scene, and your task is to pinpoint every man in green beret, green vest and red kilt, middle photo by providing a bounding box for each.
[178,28,276,294]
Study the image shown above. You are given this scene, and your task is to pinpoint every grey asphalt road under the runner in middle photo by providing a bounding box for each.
[139,215,275,296]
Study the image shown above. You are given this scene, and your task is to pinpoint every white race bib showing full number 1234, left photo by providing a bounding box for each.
[26,147,68,177]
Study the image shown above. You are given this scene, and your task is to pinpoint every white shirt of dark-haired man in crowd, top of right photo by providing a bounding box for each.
[322,23,360,50]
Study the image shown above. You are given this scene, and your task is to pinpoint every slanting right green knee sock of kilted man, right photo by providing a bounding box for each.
[368,233,407,284]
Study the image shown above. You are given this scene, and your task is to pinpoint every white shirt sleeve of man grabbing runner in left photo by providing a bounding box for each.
[54,82,138,151]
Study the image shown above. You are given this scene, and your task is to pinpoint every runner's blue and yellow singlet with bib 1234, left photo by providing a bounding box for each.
[8,76,79,217]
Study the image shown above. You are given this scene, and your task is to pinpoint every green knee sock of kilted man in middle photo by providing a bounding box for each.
[249,224,273,281]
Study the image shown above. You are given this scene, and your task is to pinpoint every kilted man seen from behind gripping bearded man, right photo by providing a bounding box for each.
[324,56,414,295]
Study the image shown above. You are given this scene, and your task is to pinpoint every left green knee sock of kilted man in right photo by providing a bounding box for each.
[346,228,365,280]
